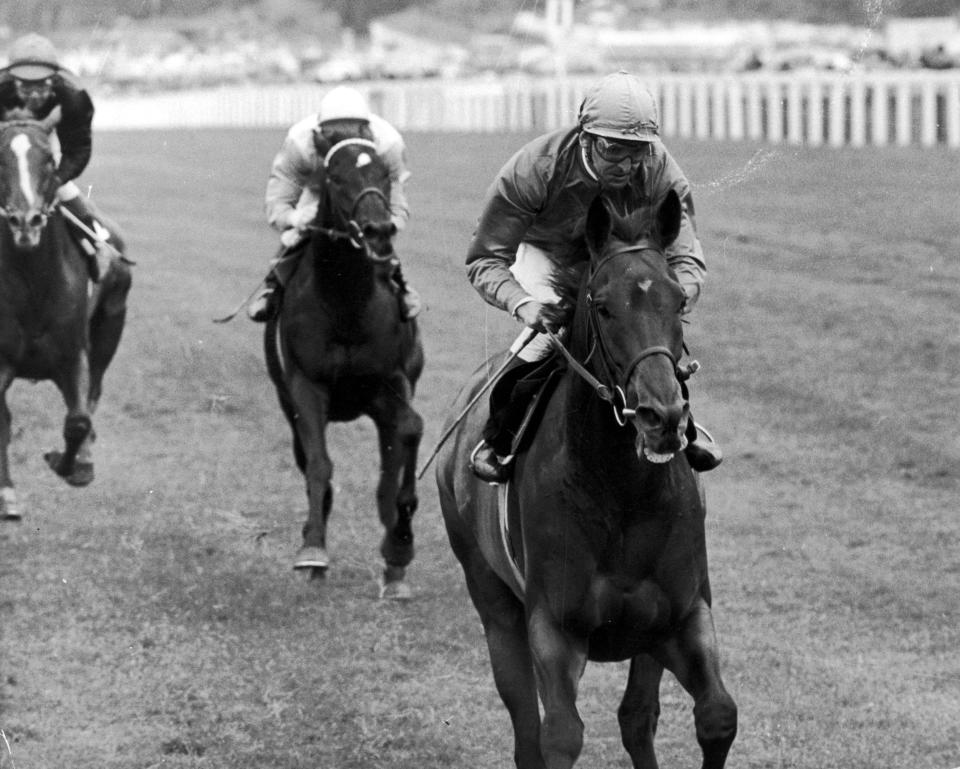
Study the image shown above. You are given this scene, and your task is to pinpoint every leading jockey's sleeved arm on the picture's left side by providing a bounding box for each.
[466,153,546,314]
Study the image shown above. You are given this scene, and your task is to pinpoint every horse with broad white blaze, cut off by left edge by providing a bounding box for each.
[0,120,131,518]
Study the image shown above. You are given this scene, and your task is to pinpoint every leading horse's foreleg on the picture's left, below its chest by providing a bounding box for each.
[527,610,587,769]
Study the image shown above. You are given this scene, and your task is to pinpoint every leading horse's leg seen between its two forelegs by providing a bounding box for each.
[617,654,663,769]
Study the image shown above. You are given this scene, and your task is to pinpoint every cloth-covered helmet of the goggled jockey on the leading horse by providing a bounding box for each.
[580,70,660,142]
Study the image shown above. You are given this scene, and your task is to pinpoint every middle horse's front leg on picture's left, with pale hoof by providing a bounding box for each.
[290,372,333,575]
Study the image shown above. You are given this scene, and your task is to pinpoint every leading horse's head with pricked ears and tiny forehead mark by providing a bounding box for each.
[576,191,690,462]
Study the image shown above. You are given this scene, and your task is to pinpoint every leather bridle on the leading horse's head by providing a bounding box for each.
[547,244,699,427]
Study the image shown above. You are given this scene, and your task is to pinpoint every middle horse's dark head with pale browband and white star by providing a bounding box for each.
[316,127,397,256]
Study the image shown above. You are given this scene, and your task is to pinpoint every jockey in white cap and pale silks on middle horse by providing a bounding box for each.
[247,86,420,321]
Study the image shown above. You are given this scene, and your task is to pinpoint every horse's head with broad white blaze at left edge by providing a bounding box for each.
[0,120,57,249]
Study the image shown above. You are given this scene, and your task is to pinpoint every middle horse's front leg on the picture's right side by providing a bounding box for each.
[372,383,423,600]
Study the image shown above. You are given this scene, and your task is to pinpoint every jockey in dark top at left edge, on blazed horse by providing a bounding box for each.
[0,34,109,280]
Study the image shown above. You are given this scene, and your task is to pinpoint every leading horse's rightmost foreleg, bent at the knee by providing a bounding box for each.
[658,598,737,769]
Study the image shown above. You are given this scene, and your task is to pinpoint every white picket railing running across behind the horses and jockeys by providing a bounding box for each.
[95,70,960,148]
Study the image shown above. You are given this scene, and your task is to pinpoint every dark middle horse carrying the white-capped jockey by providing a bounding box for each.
[264,134,424,599]
